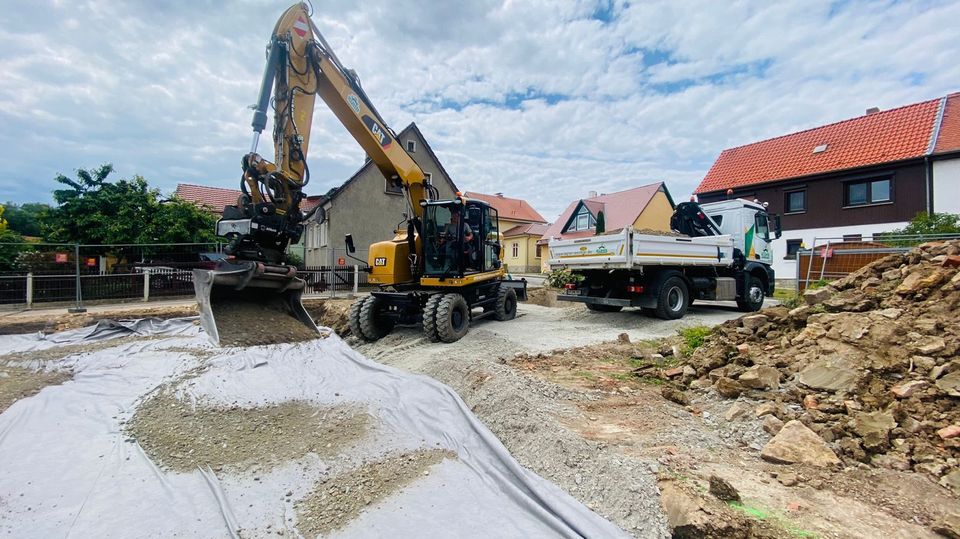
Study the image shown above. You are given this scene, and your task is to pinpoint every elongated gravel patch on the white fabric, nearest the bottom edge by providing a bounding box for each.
[294,449,457,537]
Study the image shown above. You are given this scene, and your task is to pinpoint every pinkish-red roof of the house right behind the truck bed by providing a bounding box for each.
[543,182,673,243]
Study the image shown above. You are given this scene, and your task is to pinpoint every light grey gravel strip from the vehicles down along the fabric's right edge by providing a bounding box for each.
[354,303,756,537]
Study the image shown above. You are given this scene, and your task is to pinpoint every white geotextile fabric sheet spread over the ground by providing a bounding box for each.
[0,320,625,538]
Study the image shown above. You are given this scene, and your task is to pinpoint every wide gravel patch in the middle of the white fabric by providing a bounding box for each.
[125,393,370,472]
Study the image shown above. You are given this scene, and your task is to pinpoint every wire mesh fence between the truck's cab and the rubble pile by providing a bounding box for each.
[796,233,960,293]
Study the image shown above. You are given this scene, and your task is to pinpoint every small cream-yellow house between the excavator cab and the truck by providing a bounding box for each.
[465,192,547,273]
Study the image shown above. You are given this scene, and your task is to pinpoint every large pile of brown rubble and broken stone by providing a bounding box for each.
[683,241,960,492]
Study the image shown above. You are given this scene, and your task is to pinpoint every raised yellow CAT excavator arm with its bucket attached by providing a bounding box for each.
[194,3,435,342]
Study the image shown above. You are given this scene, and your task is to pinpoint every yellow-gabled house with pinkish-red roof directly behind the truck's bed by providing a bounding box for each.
[537,182,675,272]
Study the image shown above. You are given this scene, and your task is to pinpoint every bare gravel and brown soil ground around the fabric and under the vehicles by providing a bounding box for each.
[0,284,958,537]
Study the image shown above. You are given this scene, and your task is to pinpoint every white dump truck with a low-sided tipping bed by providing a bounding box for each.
[548,199,781,320]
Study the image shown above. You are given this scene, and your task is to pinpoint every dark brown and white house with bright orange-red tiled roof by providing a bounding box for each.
[696,93,960,279]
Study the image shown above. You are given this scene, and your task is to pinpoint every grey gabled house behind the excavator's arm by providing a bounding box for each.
[304,123,457,266]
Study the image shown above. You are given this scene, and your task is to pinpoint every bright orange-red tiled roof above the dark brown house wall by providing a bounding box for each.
[695,99,942,193]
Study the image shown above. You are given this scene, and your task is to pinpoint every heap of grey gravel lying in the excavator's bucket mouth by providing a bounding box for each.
[212,301,321,346]
